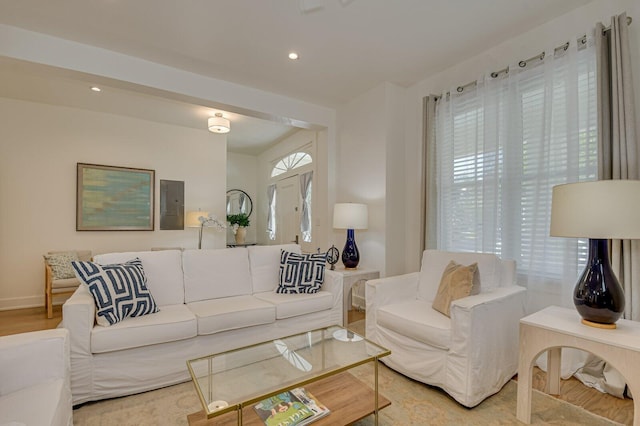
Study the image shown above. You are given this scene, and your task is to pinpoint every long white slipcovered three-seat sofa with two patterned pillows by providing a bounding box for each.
[63,244,342,404]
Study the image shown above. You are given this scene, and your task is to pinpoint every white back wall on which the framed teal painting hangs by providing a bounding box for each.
[0,98,226,309]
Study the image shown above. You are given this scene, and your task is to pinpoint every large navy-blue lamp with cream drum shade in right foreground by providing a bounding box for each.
[551,180,640,329]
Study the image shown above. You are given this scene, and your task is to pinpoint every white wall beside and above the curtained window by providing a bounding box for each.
[405,0,640,272]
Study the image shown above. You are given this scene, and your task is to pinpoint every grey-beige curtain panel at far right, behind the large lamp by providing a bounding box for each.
[596,13,640,321]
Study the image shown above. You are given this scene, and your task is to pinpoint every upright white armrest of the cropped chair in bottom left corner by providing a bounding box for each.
[0,328,70,396]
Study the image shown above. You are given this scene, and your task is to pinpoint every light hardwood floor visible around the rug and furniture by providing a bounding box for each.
[0,306,633,425]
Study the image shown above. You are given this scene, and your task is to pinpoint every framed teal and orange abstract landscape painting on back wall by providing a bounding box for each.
[76,163,155,231]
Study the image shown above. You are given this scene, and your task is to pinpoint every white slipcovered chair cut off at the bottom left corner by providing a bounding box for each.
[0,329,73,426]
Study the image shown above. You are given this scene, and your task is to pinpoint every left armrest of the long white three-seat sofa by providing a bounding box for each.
[62,285,96,355]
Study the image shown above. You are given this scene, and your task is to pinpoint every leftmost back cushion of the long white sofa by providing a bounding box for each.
[94,250,184,307]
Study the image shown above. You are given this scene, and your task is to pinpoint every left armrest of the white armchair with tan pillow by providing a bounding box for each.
[365,272,420,342]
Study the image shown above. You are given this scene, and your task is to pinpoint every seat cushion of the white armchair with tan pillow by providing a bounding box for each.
[376,300,451,350]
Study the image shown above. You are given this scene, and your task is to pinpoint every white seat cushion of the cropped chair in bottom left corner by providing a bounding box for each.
[0,379,65,425]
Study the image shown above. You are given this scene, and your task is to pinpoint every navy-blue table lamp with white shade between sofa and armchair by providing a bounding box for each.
[333,203,369,269]
